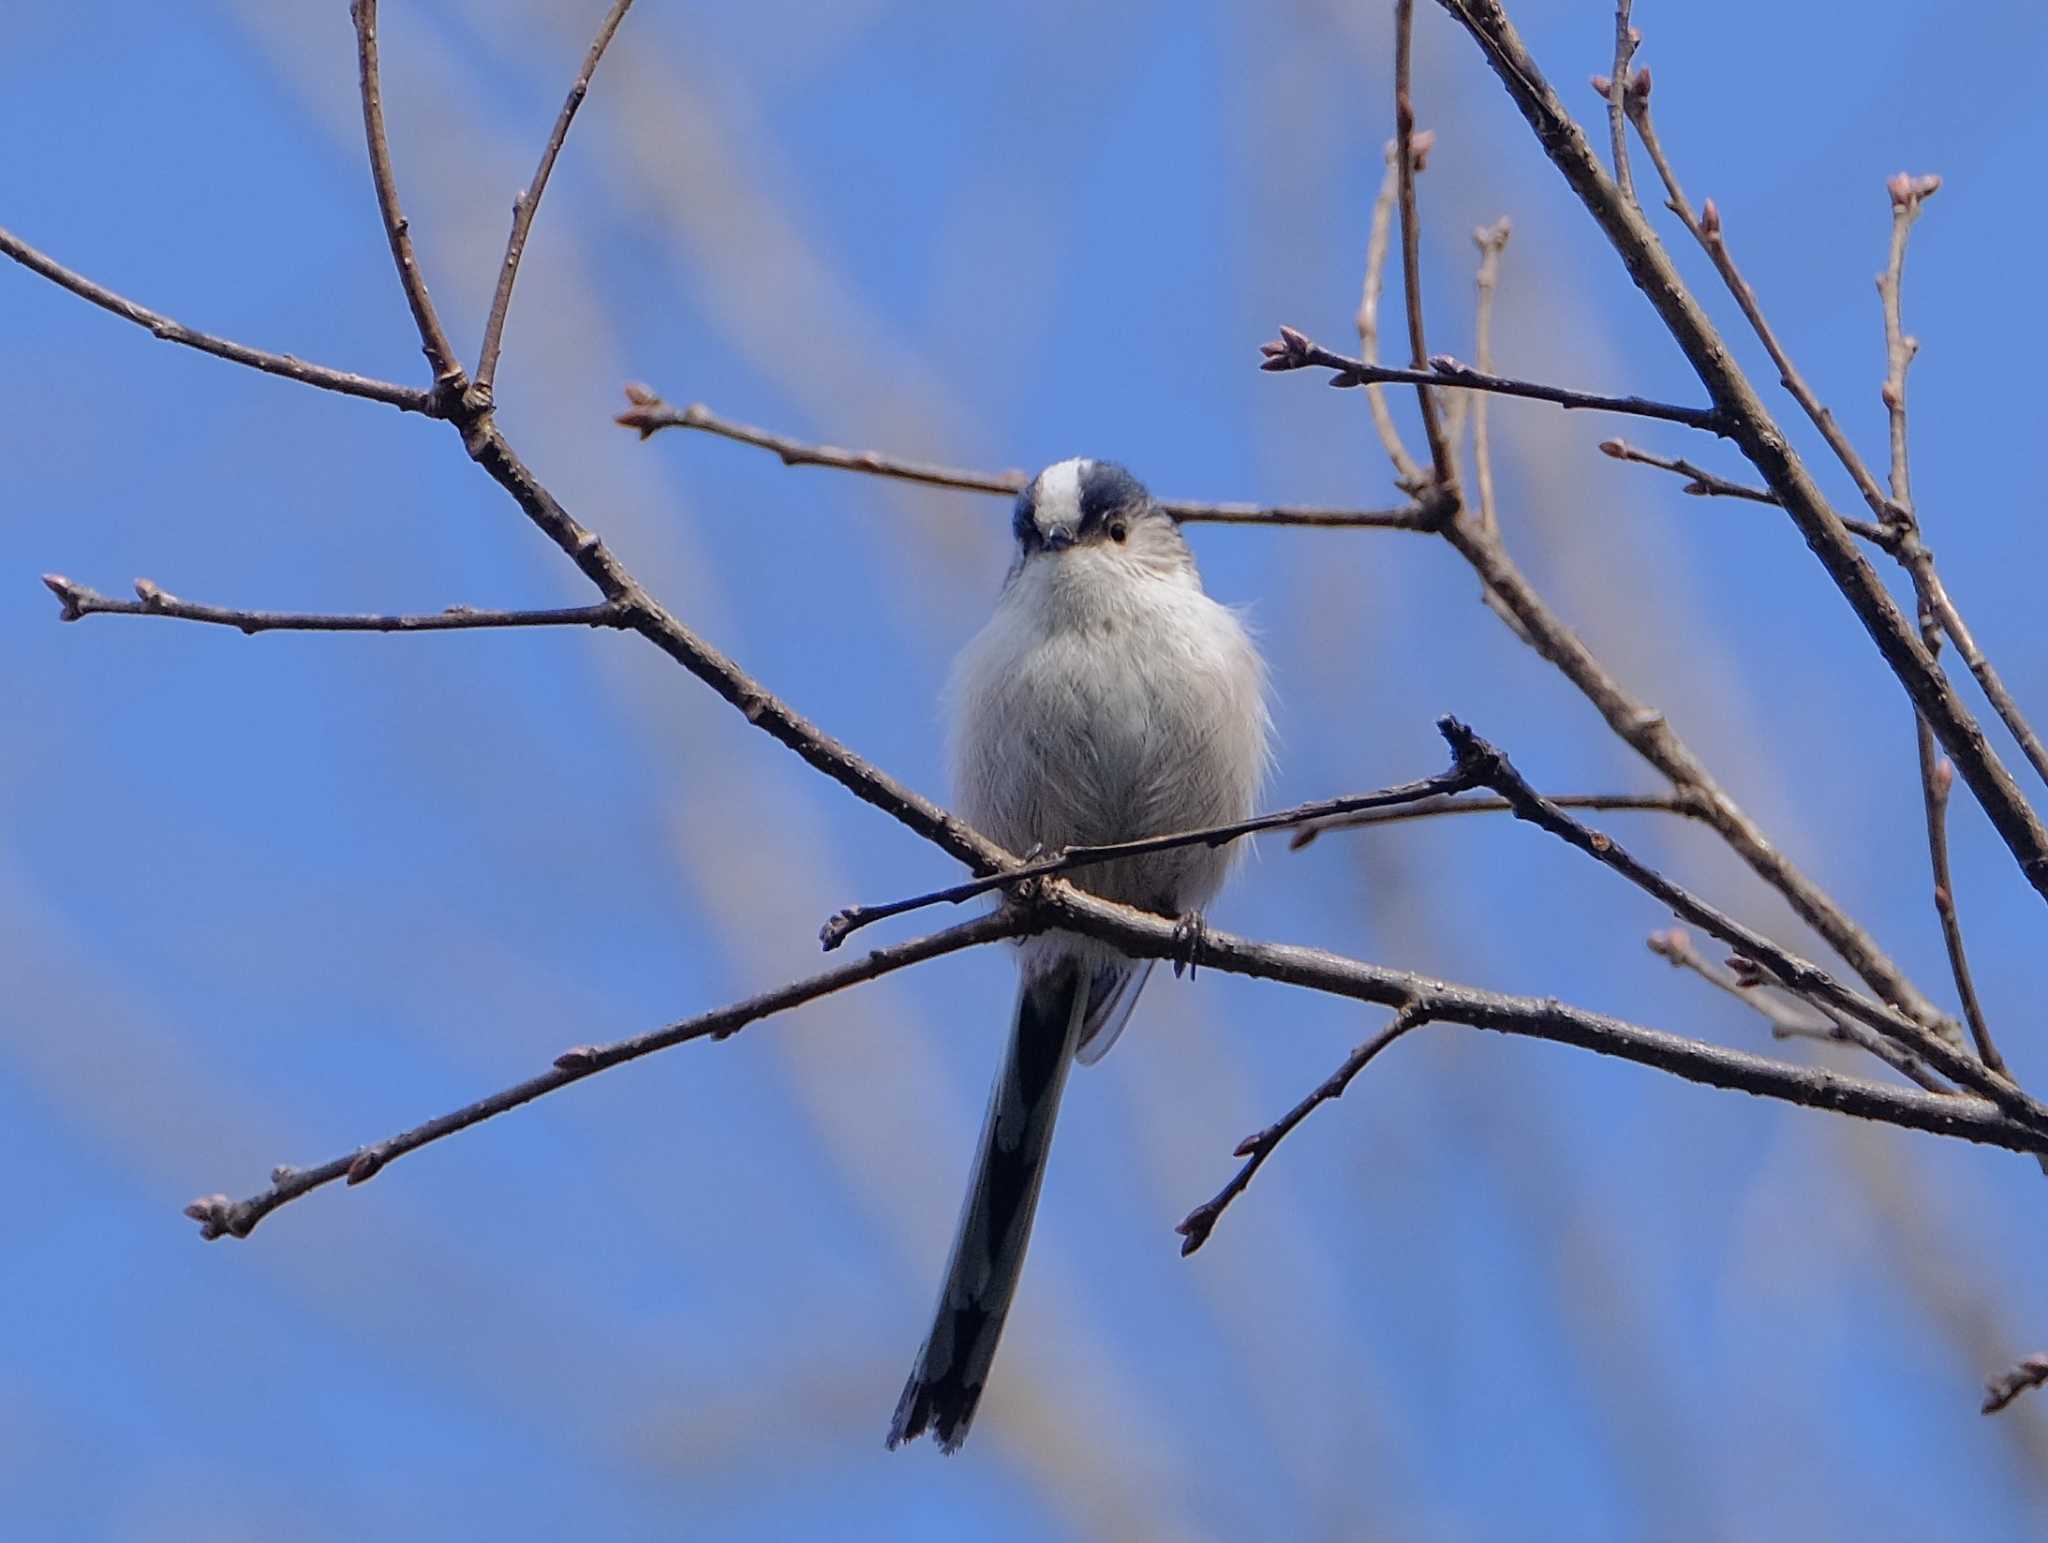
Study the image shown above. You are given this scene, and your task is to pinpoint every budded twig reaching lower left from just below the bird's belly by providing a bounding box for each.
[184,912,1034,1240]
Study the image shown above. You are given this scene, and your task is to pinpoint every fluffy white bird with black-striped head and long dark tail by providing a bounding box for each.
[889,459,1272,1453]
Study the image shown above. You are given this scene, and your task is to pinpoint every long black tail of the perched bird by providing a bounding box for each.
[889,963,1087,1453]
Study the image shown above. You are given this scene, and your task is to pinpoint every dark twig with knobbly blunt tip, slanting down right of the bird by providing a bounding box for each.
[1438,717,2048,1129]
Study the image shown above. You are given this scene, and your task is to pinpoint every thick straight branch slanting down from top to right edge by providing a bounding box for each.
[1438,0,2048,900]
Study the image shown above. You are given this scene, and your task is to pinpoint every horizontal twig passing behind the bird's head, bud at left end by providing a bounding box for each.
[612,385,1432,531]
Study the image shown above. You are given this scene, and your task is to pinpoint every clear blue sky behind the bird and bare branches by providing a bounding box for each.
[0,0,2048,1539]
